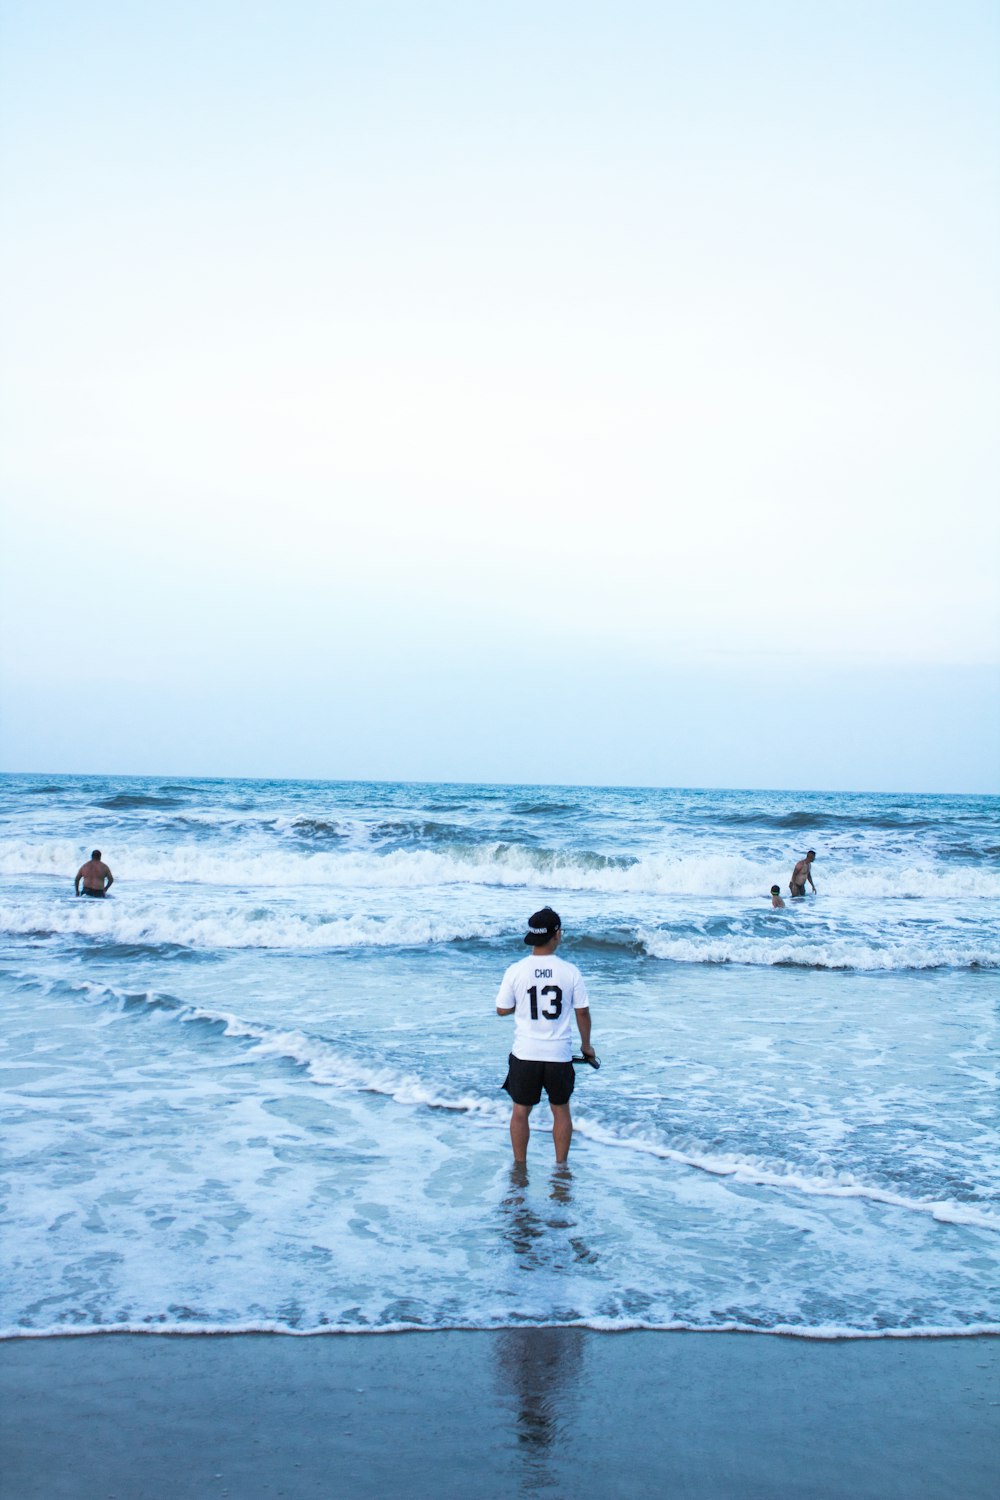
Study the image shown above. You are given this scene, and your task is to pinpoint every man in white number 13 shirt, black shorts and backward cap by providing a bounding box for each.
[496,906,594,1163]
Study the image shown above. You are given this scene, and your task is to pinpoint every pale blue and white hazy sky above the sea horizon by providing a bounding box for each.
[0,0,1000,791]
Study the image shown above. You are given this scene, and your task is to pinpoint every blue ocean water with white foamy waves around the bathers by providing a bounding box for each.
[0,776,1000,1338]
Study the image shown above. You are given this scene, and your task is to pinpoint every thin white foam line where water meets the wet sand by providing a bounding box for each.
[0,1317,1000,1344]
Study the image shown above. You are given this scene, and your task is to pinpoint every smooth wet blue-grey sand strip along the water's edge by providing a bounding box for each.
[0,1328,1000,1500]
